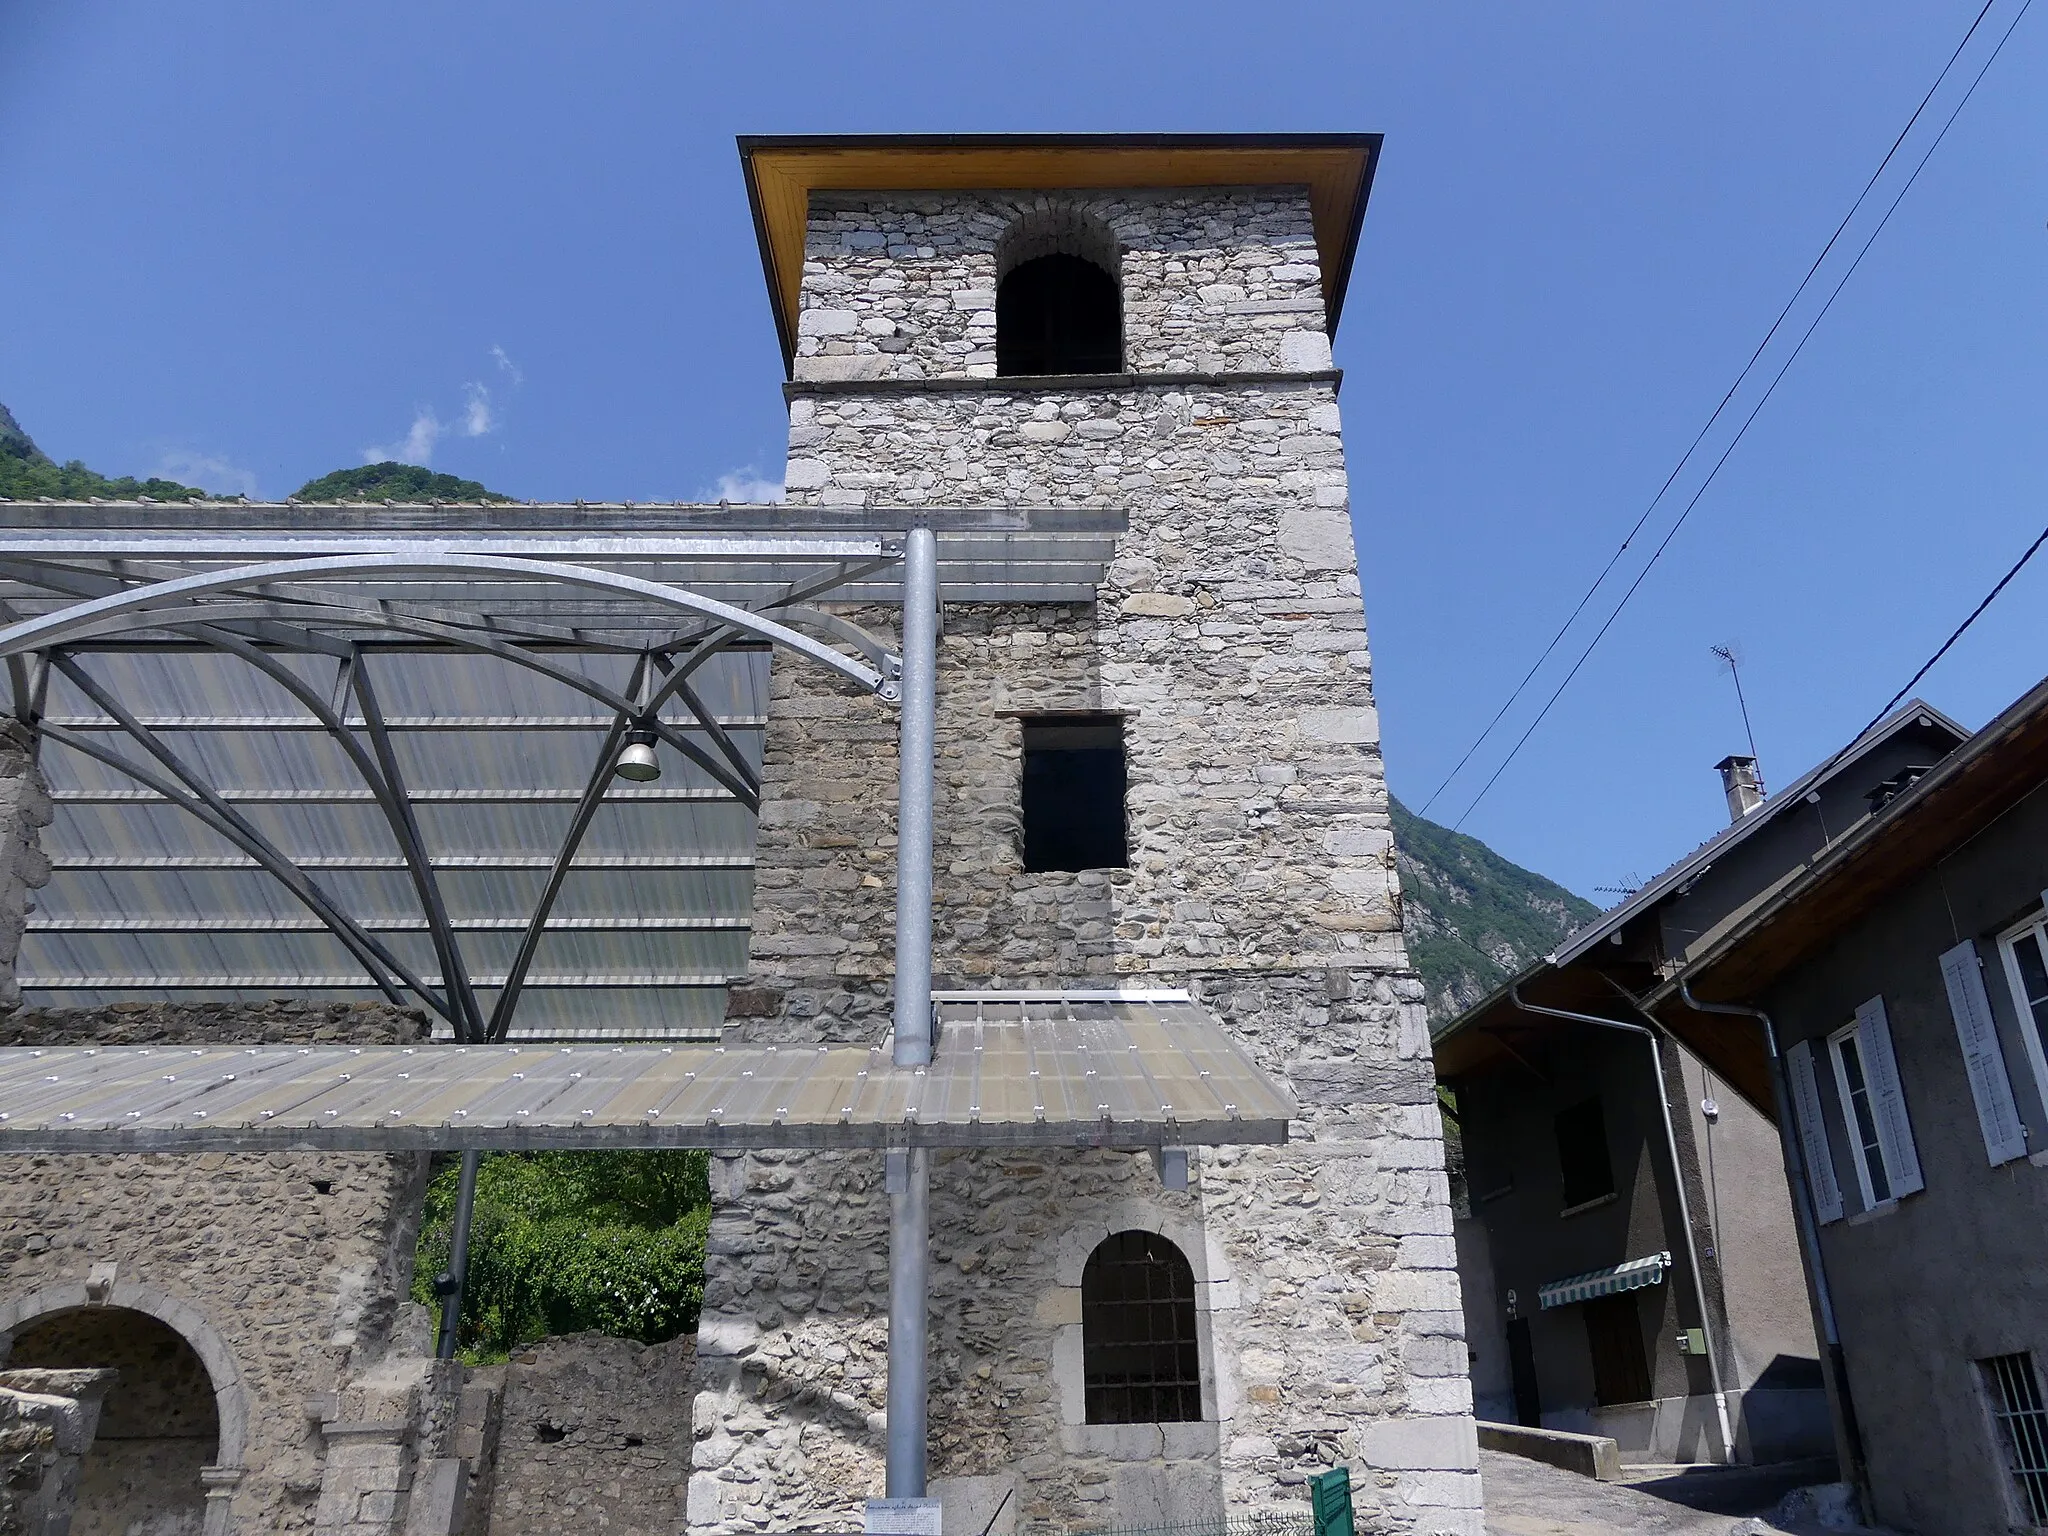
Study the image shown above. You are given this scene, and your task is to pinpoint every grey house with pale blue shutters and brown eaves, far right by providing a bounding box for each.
[1647,682,2048,1536]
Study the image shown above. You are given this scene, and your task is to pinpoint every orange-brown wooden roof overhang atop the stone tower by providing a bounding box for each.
[739,133,1382,369]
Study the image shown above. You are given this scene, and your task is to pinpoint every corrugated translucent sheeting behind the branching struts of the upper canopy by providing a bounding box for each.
[20,649,768,1038]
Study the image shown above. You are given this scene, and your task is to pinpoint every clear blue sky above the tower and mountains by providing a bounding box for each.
[0,0,2048,903]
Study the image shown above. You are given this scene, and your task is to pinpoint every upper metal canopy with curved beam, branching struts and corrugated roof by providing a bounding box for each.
[0,502,1124,1040]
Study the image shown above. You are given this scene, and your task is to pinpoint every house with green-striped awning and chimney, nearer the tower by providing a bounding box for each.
[1436,700,1968,1460]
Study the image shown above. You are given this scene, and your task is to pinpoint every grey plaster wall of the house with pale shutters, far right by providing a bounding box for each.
[1759,791,2048,1536]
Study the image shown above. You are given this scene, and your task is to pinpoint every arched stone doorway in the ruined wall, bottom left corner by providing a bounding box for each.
[6,1307,221,1536]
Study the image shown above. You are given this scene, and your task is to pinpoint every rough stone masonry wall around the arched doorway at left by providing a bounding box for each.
[0,1004,426,1532]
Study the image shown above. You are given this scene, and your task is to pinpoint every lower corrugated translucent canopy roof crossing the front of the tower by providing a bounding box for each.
[0,995,1294,1153]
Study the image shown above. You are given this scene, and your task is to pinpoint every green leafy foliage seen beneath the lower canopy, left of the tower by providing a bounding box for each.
[412,1151,711,1360]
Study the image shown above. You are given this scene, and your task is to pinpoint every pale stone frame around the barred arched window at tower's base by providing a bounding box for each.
[1047,1200,1239,1460]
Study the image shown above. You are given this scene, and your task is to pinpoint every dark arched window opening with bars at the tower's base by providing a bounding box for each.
[1081,1231,1202,1423]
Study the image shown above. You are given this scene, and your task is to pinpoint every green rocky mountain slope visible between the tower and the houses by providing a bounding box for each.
[1389,797,1599,1024]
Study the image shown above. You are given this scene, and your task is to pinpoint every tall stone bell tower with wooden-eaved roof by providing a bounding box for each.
[688,135,1481,1536]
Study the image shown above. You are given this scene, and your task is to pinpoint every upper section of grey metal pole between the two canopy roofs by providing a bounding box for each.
[895,528,938,1067]
